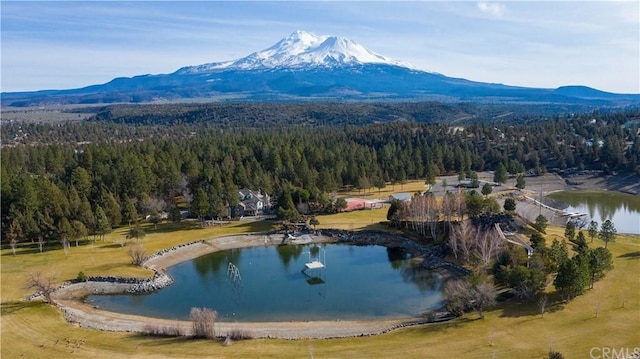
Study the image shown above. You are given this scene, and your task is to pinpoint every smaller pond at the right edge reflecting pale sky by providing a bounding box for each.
[549,191,640,234]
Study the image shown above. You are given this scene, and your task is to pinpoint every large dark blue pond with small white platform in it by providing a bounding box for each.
[87,244,443,321]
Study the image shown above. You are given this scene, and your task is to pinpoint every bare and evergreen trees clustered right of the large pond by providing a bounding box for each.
[440,207,616,317]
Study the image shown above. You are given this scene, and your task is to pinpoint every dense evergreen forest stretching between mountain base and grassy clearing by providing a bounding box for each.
[0,104,640,249]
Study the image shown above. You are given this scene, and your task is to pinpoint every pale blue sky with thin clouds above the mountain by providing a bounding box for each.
[0,0,640,93]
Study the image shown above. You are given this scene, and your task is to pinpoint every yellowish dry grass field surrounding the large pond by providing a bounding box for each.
[0,183,640,359]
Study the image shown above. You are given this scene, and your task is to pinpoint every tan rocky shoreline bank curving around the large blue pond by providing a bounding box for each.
[37,230,467,339]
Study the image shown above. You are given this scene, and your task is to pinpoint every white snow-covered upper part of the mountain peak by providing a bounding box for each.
[178,31,415,74]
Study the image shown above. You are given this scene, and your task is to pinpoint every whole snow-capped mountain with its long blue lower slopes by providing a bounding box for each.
[2,31,640,106]
